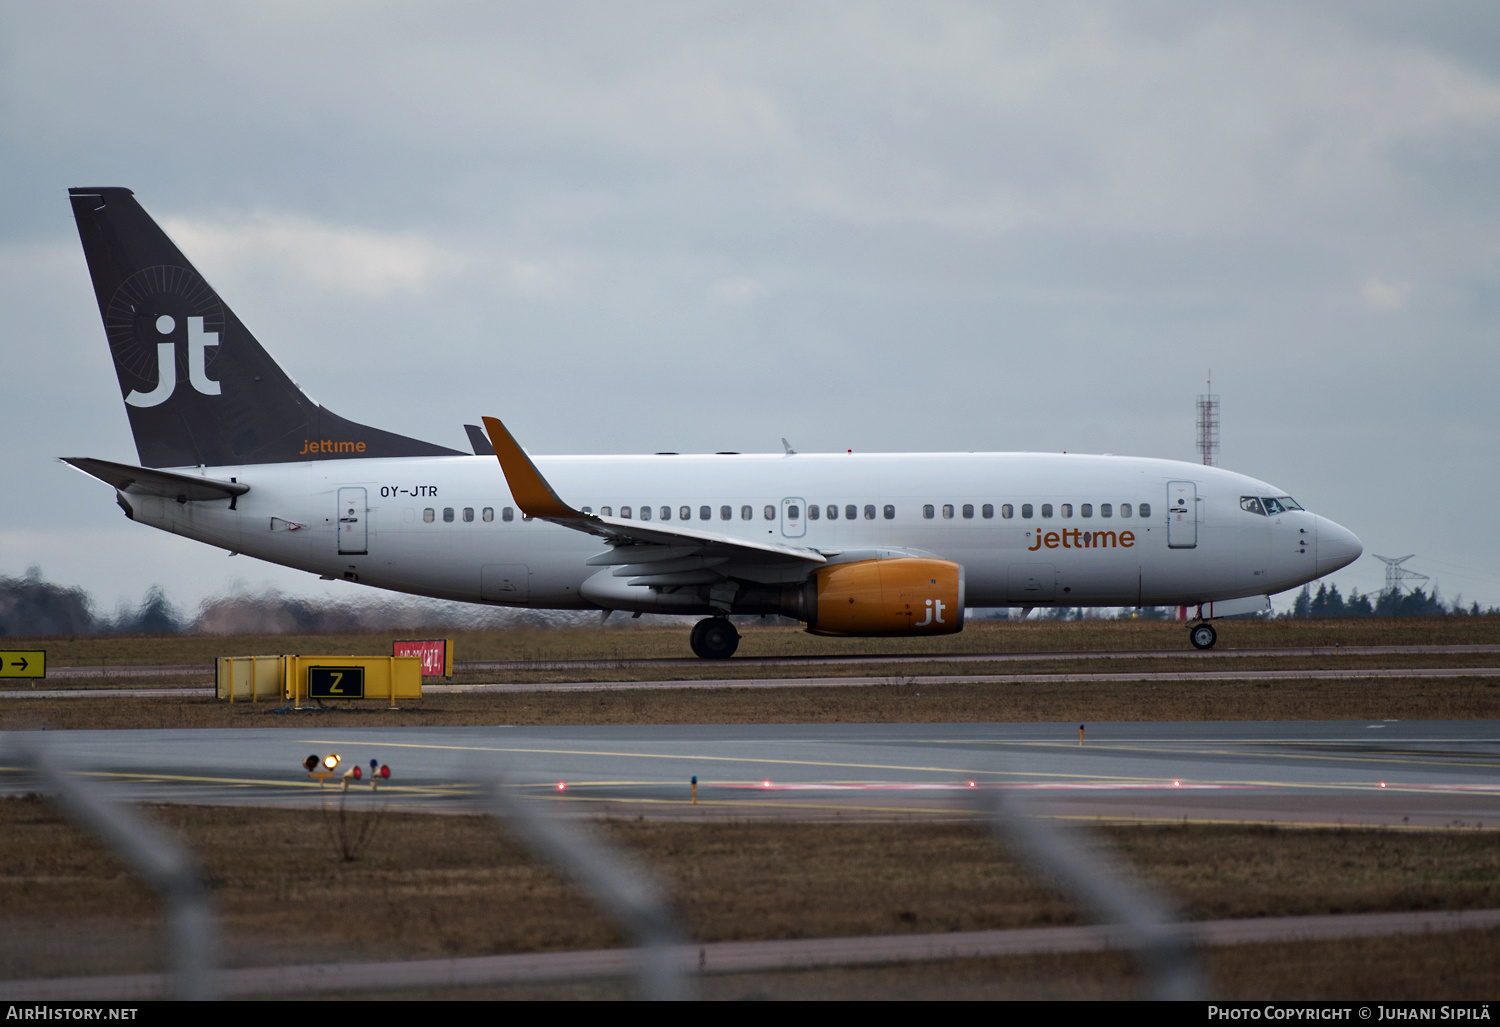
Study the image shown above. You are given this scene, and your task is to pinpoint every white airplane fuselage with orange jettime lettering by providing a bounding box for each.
[125,453,1361,610]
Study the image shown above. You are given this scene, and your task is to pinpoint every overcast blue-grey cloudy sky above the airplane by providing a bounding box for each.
[0,0,1500,609]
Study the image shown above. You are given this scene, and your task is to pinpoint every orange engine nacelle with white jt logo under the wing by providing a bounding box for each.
[798,556,963,634]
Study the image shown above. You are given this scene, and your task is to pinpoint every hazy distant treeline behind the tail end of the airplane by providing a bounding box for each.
[0,567,597,637]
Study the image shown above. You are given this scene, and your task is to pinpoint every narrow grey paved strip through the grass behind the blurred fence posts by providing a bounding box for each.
[0,910,1500,1002]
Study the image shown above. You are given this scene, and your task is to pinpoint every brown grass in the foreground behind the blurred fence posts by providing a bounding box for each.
[0,798,1500,999]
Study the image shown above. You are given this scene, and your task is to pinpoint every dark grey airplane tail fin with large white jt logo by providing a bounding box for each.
[68,187,459,468]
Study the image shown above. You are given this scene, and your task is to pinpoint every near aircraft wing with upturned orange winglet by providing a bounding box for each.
[485,417,828,564]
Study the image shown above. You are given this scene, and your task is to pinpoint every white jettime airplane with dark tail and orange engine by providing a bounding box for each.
[66,187,1362,658]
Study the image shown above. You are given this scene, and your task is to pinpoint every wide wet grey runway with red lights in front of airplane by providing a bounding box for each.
[0,715,1500,829]
